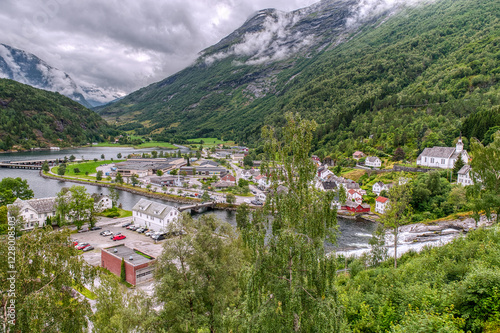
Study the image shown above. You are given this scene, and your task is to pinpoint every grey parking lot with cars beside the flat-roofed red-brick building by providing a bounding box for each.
[71,220,168,266]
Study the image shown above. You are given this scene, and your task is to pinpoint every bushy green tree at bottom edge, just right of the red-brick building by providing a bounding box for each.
[155,214,245,332]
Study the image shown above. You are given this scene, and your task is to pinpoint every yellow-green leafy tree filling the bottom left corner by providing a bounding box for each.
[0,226,95,332]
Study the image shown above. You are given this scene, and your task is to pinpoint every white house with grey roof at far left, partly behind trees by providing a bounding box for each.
[7,197,56,230]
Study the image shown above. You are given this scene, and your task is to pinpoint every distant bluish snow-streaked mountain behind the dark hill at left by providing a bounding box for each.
[0,44,121,108]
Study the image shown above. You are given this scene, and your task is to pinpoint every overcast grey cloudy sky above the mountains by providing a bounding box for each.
[0,0,318,93]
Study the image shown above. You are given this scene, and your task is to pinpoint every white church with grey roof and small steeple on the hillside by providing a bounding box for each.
[417,138,469,169]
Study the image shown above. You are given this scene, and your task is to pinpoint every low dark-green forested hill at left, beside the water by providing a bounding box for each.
[0,79,118,150]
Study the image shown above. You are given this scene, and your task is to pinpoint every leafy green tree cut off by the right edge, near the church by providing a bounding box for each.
[471,133,500,223]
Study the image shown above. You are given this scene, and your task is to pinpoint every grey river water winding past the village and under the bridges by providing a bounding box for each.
[0,147,376,251]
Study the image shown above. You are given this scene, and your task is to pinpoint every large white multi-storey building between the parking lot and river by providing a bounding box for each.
[132,199,179,231]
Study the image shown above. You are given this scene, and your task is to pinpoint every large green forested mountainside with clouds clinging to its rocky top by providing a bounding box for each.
[99,0,500,156]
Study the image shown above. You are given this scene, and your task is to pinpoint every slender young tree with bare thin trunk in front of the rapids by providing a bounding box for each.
[381,176,412,268]
